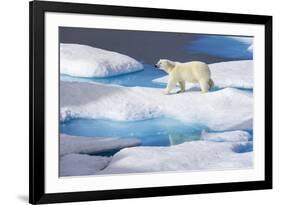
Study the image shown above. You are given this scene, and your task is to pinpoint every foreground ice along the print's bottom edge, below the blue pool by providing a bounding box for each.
[60,131,253,176]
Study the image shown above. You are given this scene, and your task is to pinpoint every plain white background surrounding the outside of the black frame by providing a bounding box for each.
[0,0,281,205]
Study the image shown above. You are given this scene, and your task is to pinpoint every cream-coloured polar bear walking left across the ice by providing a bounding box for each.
[155,59,214,94]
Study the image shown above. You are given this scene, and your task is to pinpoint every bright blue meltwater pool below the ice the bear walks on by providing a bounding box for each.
[60,118,206,146]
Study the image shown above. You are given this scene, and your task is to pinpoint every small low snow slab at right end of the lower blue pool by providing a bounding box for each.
[201,130,251,142]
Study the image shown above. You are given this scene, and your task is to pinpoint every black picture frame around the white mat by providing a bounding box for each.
[29,1,272,204]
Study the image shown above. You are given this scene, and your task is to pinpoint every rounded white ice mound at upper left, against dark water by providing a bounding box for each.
[60,43,143,77]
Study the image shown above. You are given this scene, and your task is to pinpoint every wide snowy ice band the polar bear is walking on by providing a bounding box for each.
[60,82,253,130]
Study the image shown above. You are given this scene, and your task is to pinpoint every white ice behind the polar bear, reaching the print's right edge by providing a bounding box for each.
[153,60,253,89]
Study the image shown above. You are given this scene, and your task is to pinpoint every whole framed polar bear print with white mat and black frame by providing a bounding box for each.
[29,1,272,204]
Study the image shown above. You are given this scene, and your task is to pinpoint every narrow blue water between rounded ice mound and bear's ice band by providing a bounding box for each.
[61,64,167,88]
